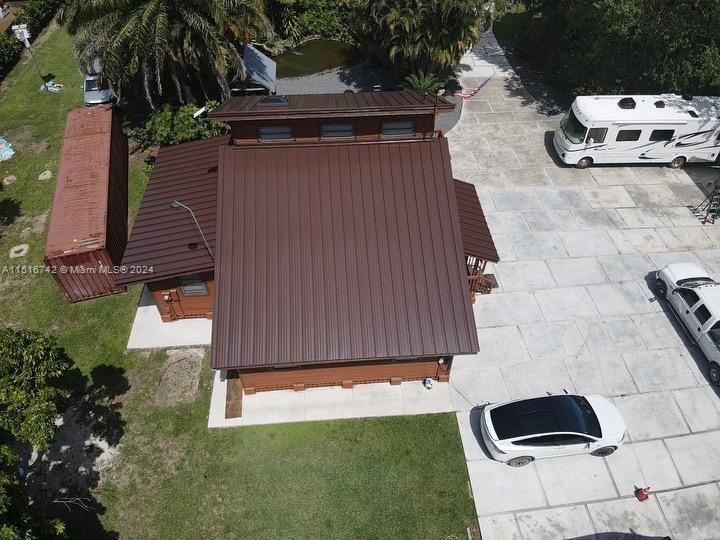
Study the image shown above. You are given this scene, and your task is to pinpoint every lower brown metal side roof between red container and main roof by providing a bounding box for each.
[115,136,230,284]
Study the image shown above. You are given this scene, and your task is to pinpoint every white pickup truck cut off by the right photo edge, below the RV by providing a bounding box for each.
[655,263,720,385]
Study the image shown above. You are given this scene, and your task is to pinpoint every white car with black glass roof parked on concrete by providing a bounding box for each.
[480,395,625,467]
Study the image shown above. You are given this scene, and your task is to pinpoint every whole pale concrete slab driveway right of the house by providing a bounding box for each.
[448,30,720,540]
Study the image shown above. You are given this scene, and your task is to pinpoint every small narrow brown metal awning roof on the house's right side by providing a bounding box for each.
[455,180,500,262]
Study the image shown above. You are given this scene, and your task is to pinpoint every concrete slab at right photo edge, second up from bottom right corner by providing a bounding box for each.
[665,431,720,486]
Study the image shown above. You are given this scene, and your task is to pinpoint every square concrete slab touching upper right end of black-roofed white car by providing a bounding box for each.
[614,392,689,441]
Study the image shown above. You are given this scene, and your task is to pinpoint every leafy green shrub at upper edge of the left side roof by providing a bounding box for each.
[130,101,230,149]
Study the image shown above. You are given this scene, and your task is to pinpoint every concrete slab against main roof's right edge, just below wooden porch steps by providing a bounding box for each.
[473,292,543,328]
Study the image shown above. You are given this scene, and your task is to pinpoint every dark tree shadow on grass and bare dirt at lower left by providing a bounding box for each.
[20,364,130,538]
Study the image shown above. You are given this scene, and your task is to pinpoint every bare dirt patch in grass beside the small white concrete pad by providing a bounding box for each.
[153,349,205,407]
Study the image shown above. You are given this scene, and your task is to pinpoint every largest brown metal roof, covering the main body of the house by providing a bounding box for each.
[212,138,478,369]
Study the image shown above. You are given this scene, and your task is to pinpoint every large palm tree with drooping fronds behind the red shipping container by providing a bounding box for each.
[60,0,271,108]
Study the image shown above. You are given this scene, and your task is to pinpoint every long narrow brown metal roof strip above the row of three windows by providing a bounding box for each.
[210,90,455,121]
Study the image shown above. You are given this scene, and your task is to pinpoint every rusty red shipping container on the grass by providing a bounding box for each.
[45,105,128,302]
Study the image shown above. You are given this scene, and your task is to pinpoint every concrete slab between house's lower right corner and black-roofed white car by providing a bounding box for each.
[450,360,522,411]
